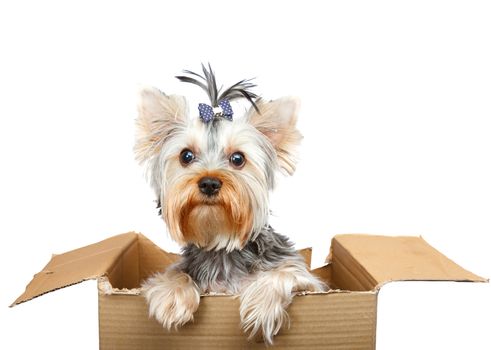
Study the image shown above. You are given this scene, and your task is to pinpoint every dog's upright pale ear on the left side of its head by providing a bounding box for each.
[134,88,188,163]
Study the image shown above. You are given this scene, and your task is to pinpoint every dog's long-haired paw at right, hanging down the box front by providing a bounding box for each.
[240,281,291,345]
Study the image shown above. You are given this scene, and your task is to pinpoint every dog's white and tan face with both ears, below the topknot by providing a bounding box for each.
[135,89,301,250]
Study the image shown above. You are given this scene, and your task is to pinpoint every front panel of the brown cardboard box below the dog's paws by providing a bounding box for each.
[99,292,377,350]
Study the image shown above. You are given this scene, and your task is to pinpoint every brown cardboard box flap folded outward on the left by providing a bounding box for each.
[11,232,177,306]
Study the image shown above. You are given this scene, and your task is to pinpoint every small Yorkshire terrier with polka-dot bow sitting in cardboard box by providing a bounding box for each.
[135,66,326,344]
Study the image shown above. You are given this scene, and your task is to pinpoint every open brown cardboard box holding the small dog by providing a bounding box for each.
[11,232,487,349]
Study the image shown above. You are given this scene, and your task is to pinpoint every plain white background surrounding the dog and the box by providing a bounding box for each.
[0,0,491,349]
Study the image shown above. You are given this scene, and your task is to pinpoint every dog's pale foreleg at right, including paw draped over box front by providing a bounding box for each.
[240,261,325,344]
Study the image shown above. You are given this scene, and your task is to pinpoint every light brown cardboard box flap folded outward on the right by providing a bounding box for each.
[330,234,487,290]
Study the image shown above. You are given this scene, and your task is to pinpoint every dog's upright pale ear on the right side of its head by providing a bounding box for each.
[246,97,302,175]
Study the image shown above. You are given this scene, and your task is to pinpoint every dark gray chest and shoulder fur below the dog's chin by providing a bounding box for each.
[174,226,305,294]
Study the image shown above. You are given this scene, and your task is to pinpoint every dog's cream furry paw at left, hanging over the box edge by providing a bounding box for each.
[142,271,200,330]
